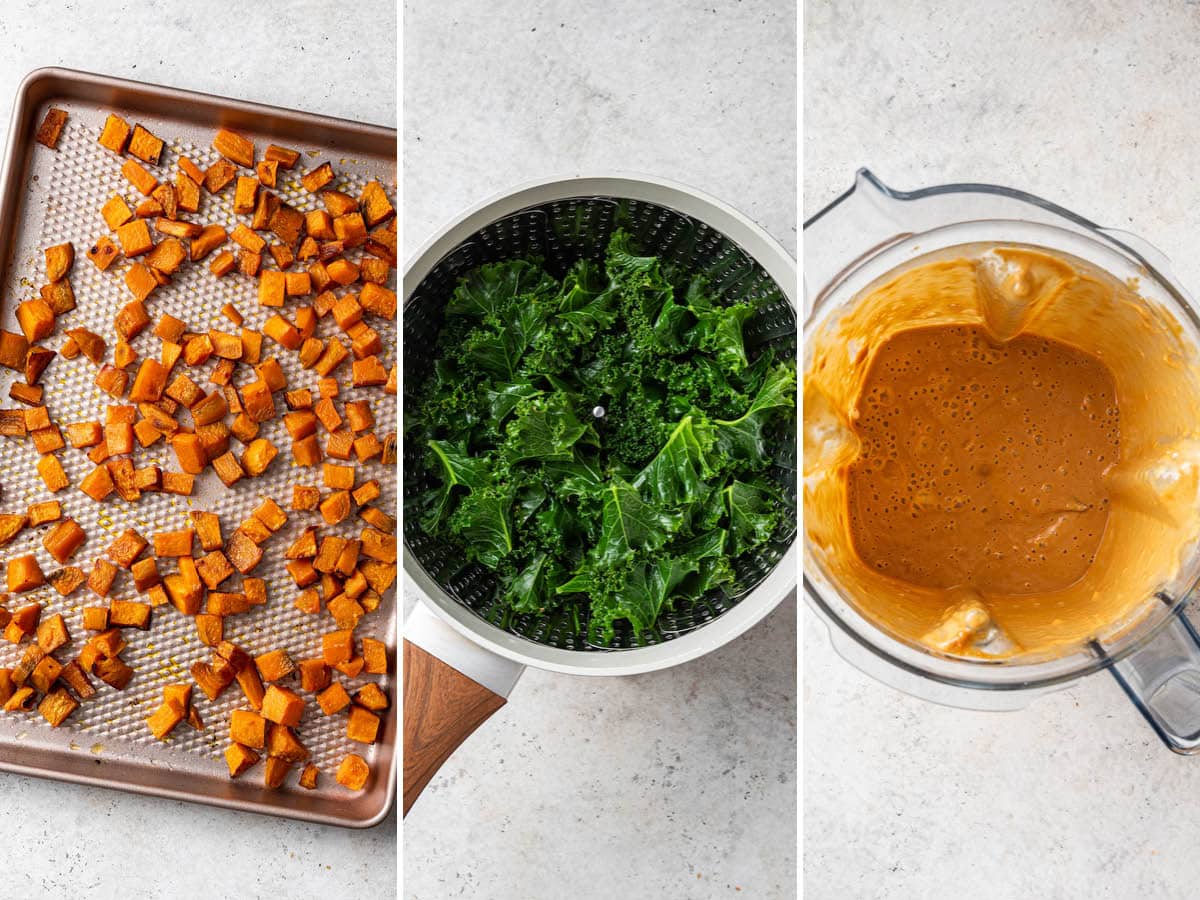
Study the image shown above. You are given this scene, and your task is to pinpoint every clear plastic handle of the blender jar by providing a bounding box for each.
[1111,604,1200,754]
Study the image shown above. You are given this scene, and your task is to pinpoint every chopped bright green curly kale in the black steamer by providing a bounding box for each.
[406,230,796,643]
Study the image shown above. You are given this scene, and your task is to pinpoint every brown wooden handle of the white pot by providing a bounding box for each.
[404,641,505,816]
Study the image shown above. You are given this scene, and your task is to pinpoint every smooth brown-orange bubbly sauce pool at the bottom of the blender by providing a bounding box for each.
[847,325,1120,594]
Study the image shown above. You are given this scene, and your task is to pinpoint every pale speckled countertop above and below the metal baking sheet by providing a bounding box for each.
[0,0,397,900]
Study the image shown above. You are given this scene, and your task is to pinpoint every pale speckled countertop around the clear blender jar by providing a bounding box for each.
[803,0,1200,900]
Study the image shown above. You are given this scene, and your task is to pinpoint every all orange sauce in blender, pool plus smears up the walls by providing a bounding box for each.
[804,245,1200,658]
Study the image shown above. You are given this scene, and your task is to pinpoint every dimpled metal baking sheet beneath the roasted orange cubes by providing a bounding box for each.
[0,70,397,826]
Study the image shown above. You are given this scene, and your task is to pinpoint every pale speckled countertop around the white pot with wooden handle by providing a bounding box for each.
[403,0,797,900]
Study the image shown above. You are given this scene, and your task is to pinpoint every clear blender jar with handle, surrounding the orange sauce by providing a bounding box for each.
[803,169,1200,752]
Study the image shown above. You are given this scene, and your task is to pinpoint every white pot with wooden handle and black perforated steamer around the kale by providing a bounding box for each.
[403,176,797,811]
